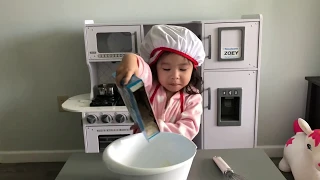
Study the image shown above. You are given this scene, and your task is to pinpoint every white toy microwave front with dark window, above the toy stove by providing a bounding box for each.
[84,24,141,61]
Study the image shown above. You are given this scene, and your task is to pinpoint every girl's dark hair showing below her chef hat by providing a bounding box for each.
[150,52,203,95]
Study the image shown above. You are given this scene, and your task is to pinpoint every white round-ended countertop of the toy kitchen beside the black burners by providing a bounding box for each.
[62,93,127,112]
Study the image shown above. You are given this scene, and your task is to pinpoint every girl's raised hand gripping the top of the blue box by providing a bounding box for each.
[116,53,139,87]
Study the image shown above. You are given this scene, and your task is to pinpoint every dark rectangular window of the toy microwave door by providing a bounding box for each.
[96,32,133,53]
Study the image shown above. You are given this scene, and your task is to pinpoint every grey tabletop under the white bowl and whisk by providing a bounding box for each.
[56,148,286,180]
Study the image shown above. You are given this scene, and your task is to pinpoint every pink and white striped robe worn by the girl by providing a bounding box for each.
[138,56,203,140]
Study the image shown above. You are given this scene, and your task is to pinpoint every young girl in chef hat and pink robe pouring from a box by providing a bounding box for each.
[116,25,205,140]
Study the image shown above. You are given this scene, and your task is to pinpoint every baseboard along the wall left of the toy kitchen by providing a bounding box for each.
[0,150,84,163]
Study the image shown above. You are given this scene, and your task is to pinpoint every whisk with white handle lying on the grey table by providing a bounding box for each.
[212,156,245,180]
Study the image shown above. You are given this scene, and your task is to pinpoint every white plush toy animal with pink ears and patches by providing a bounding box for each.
[279,118,320,180]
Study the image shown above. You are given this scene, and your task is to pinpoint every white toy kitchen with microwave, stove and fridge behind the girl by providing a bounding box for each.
[62,14,262,153]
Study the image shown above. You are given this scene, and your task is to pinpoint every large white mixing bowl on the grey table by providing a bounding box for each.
[103,132,197,180]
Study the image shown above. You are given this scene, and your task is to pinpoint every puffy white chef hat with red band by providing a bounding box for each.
[140,25,205,67]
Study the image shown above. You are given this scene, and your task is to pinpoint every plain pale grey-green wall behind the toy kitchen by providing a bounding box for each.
[0,0,320,160]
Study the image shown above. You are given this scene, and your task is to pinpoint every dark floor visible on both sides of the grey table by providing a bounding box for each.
[0,158,294,180]
